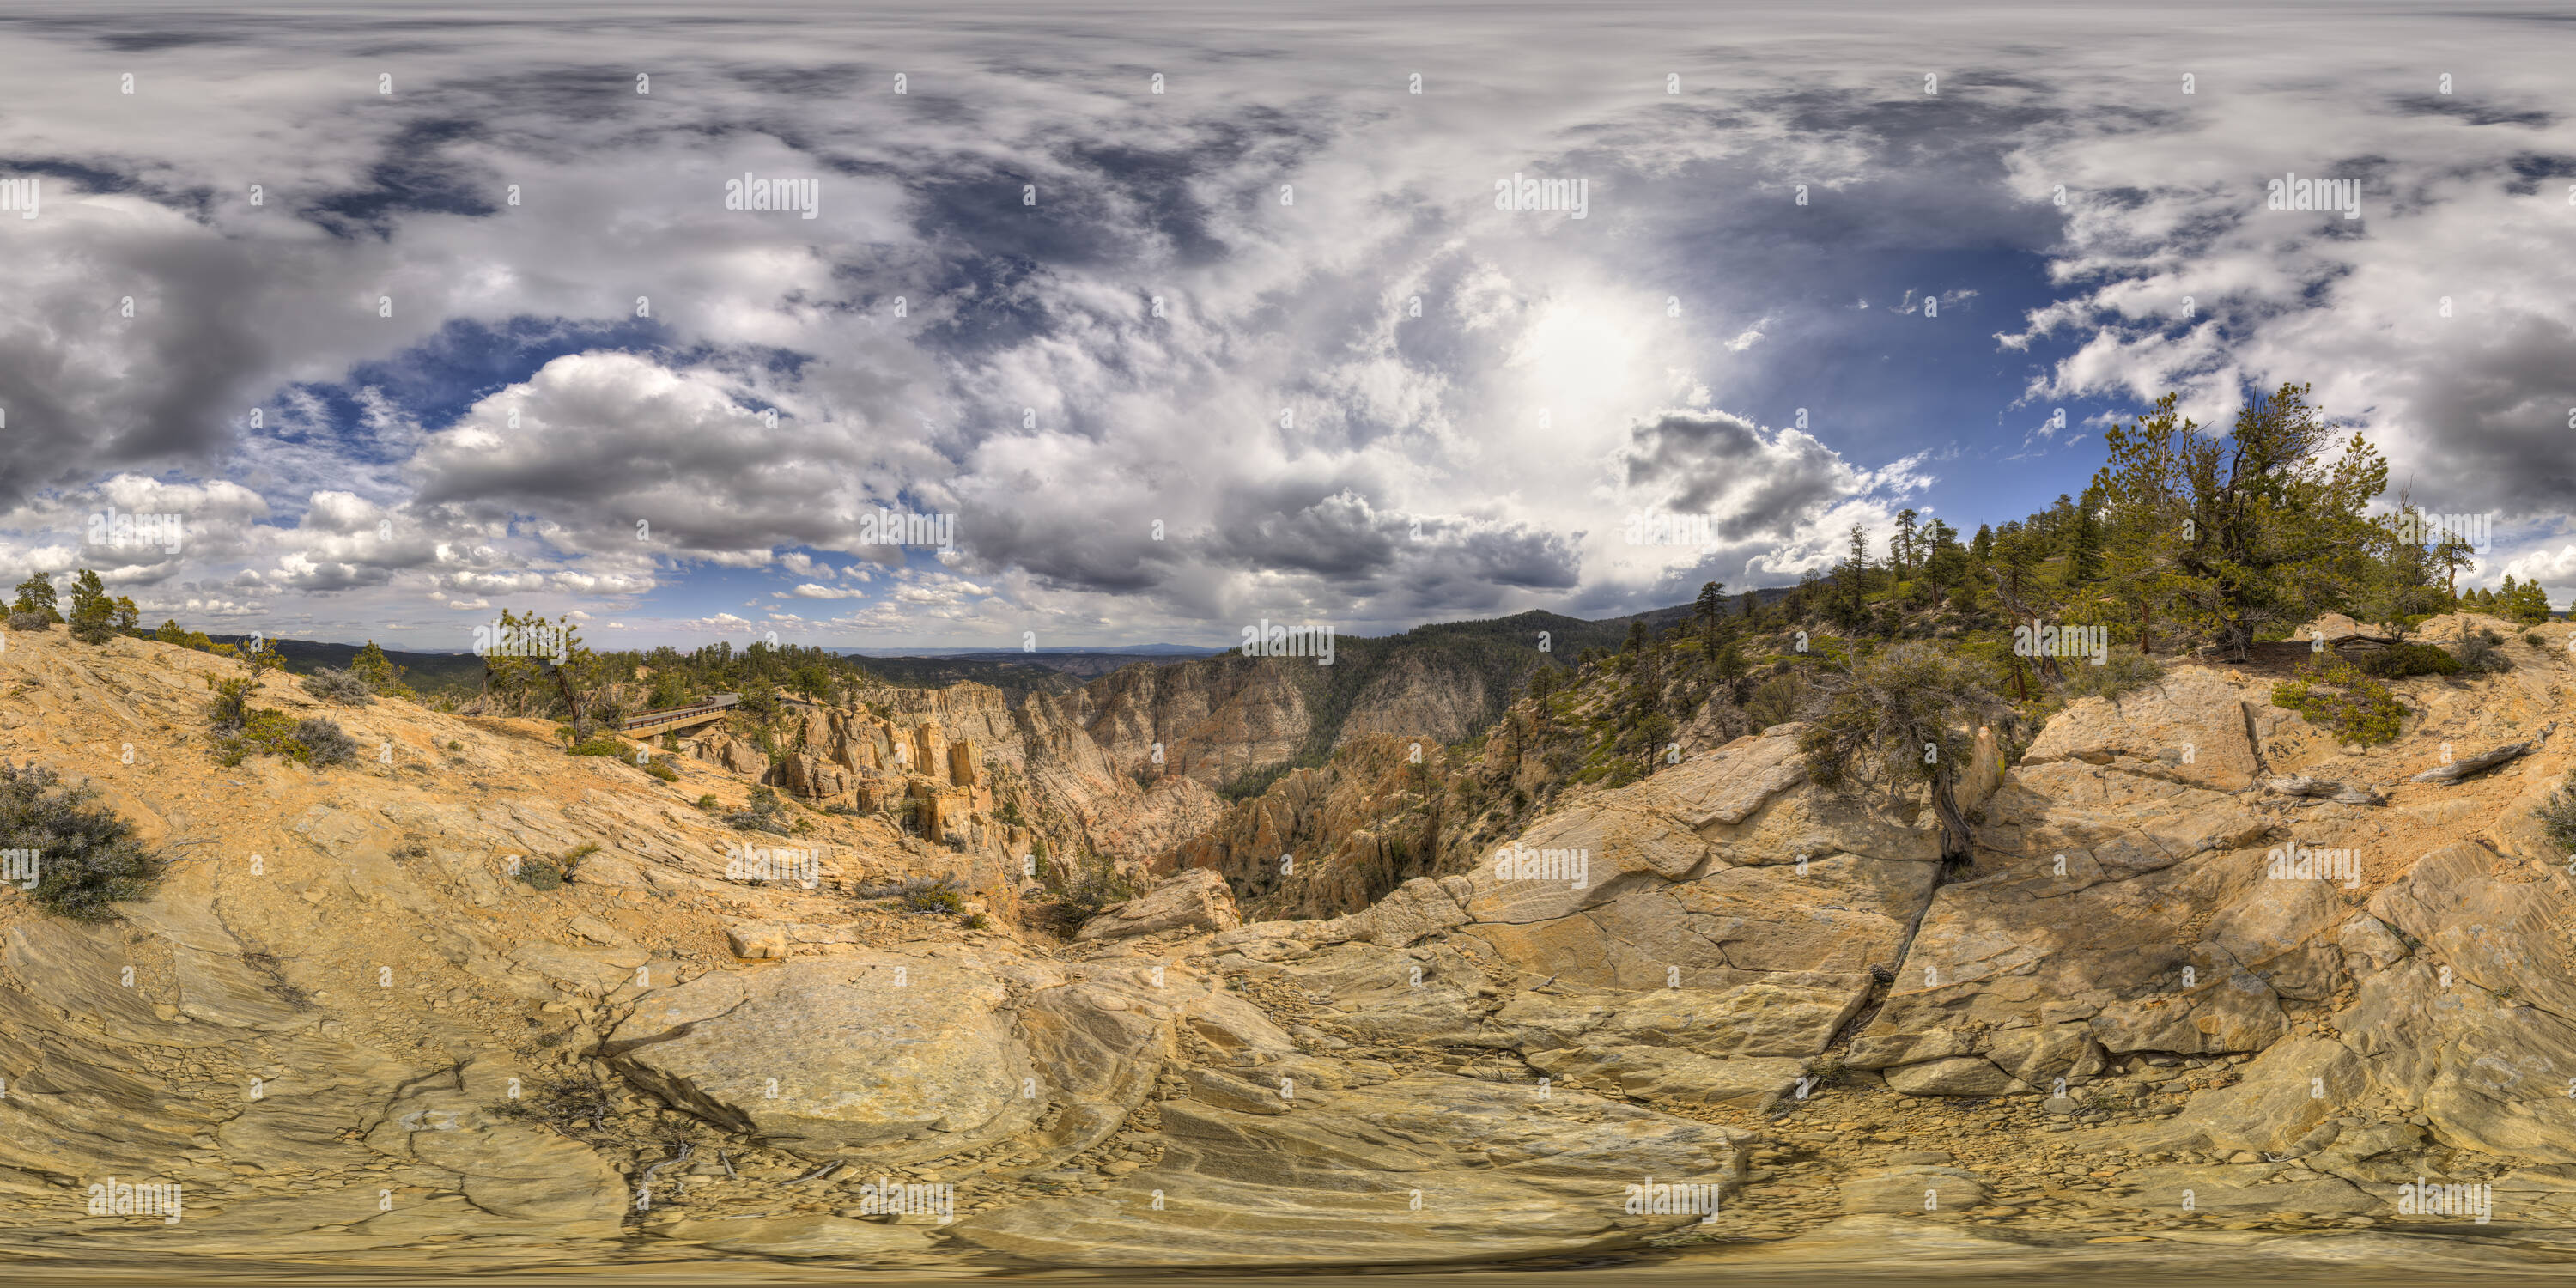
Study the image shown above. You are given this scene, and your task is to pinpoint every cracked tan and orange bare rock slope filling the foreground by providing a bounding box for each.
[15,626,2576,1273]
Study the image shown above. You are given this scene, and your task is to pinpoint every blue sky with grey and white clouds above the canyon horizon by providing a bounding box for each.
[0,3,2576,649]
